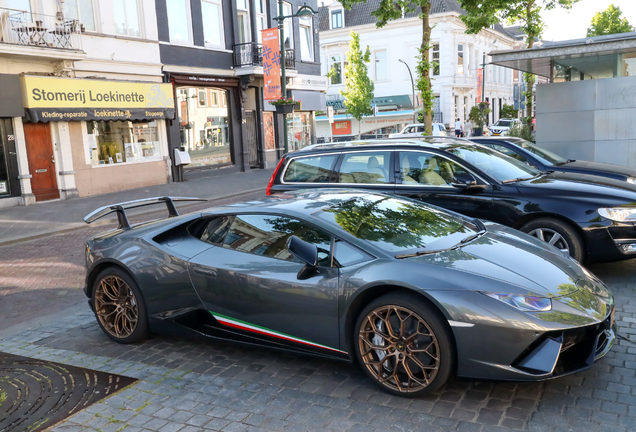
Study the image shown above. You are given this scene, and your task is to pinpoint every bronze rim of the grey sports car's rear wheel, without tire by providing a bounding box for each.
[95,275,139,339]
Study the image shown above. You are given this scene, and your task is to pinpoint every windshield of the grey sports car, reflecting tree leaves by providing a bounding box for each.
[318,195,478,253]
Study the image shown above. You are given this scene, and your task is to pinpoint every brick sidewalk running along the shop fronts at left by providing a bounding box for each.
[0,170,273,245]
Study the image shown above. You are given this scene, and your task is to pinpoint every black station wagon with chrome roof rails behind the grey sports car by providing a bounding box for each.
[267,137,636,262]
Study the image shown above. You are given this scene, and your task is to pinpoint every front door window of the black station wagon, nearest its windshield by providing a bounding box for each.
[399,152,471,187]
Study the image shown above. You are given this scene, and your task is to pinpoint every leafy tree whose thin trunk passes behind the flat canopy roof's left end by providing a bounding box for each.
[459,0,579,123]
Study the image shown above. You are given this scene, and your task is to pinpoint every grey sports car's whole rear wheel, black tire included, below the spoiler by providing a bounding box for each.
[91,267,149,344]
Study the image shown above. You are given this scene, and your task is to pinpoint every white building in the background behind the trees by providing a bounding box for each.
[316,0,516,138]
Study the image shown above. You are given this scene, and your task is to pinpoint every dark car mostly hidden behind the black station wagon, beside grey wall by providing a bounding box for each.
[470,137,636,184]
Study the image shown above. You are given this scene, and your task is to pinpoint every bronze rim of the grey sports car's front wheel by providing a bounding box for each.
[358,305,440,393]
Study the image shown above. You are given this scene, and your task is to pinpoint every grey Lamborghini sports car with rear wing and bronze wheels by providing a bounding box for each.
[85,189,615,396]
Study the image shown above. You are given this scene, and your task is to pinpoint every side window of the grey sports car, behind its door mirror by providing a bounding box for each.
[223,215,331,267]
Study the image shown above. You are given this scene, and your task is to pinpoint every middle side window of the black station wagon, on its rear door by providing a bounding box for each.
[338,152,391,184]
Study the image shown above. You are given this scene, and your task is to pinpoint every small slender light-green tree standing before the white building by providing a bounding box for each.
[340,32,375,139]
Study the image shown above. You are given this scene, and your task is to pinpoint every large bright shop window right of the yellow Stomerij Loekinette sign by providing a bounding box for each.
[170,74,241,173]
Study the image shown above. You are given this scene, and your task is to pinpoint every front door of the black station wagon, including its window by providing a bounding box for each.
[395,150,494,220]
